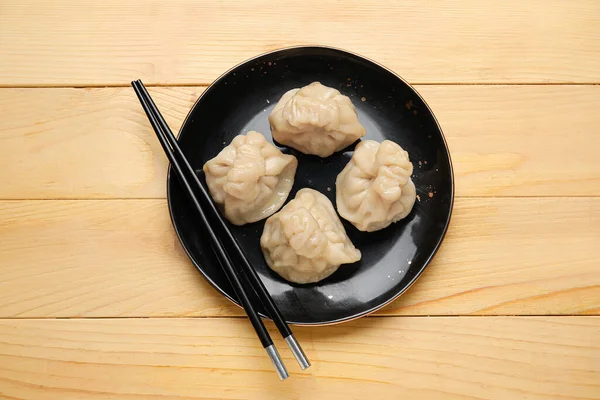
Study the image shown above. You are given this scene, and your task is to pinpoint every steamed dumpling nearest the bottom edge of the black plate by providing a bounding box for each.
[260,188,361,283]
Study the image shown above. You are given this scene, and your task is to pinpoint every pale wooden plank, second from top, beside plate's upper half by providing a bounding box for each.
[0,86,600,199]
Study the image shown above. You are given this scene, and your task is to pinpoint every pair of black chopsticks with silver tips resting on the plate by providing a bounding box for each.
[131,80,310,380]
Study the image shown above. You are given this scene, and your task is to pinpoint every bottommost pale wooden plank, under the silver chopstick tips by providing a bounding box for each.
[0,317,600,400]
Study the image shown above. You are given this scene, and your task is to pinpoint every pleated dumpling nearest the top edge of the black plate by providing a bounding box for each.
[269,82,365,157]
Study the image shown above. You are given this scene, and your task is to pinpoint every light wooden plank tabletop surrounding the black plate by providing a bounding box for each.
[0,0,600,400]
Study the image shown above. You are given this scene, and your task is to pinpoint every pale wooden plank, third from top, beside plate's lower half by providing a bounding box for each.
[0,198,600,318]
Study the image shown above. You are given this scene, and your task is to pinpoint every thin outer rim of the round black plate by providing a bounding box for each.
[166,45,455,326]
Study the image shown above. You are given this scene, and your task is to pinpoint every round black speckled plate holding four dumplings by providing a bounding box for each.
[168,47,454,324]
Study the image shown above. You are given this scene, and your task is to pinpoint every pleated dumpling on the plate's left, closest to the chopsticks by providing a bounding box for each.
[203,131,298,225]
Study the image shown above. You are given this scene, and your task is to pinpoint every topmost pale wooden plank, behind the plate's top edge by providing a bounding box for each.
[0,0,600,86]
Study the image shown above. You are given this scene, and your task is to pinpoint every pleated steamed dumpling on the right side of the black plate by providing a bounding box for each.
[335,140,417,232]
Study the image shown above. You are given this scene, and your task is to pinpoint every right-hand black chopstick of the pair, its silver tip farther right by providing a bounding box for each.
[132,80,310,369]
